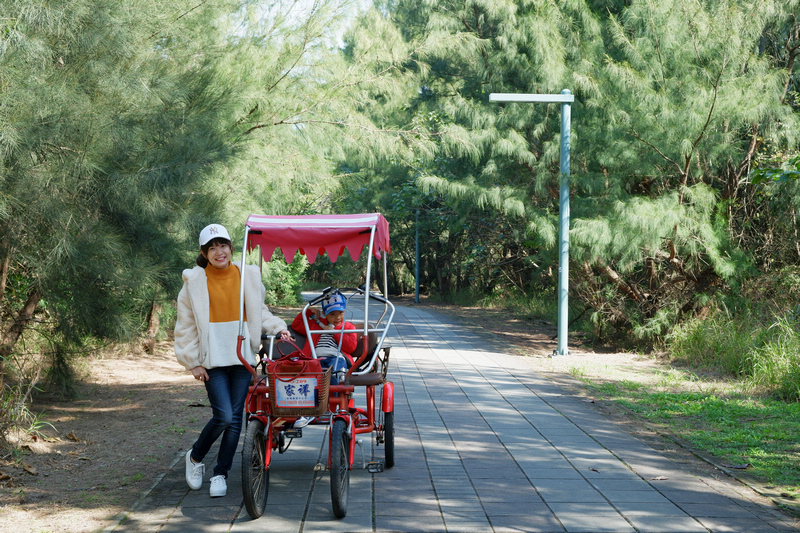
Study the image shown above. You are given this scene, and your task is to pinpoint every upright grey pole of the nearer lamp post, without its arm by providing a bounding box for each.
[556,89,572,355]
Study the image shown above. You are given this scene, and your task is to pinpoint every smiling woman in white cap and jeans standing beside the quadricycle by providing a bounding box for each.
[175,224,290,498]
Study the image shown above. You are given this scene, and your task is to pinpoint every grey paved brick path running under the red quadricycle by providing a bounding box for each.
[108,306,800,533]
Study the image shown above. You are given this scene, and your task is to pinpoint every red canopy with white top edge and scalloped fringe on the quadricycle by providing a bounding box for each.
[246,213,389,263]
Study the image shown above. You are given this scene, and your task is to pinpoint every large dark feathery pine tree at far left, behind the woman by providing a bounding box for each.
[0,0,252,390]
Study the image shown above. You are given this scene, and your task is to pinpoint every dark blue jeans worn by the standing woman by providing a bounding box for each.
[192,365,252,478]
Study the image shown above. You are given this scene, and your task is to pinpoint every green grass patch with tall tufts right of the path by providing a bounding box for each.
[648,307,800,497]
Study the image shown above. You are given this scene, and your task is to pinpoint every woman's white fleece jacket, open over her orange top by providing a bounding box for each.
[175,263,286,370]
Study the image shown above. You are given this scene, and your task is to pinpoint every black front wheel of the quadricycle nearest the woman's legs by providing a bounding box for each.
[242,420,271,519]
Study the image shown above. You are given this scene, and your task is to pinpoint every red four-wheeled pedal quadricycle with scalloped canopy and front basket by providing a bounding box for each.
[237,213,394,518]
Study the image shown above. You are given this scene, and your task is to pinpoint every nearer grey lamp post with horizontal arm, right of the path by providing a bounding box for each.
[489,89,575,355]
